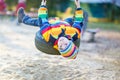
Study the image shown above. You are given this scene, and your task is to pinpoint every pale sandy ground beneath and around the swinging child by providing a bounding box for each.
[0,21,120,80]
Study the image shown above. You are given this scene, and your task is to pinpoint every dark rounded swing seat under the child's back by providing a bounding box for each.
[35,31,80,55]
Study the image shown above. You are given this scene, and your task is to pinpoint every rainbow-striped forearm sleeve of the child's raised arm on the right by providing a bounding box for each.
[74,8,83,22]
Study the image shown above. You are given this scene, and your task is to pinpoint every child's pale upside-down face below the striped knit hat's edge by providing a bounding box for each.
[58,37,70,50]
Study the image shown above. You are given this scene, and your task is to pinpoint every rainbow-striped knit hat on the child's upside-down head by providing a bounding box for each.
[59,41,78,59]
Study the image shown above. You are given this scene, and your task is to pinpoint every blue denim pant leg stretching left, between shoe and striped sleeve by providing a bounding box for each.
[23,16,39,26]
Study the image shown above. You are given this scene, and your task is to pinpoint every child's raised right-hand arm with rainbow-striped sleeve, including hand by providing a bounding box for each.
[73,0,83,32]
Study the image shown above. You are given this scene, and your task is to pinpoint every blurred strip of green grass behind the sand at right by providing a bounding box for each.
[88,22,120,32]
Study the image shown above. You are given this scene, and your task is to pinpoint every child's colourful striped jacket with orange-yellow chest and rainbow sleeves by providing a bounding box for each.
[38,6,83,49]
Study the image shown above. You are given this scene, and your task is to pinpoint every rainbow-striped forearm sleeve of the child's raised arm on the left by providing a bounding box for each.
[38,5,48,19]
